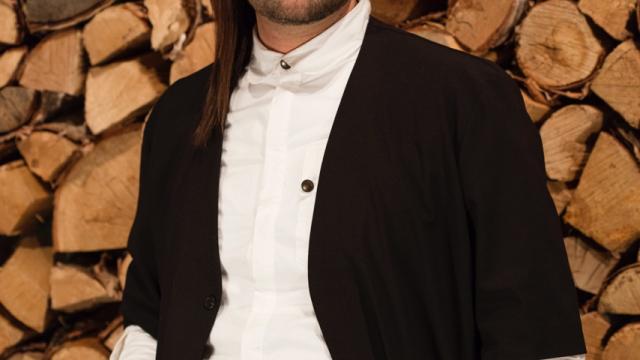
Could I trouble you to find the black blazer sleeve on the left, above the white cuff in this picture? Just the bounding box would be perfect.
[120,99,161,339]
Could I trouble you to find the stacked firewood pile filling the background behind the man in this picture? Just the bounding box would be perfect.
[0,0,640,360]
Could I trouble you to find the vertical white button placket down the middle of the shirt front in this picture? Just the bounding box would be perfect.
[242,81,292,360]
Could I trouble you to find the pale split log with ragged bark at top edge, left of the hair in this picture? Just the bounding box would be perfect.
[144,0,200,52]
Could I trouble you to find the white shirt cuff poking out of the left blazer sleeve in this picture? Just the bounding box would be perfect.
[109,325,157,360]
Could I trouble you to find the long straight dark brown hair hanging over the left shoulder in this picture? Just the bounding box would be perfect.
[192,0,256,148]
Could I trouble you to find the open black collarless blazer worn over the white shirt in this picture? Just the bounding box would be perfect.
[121,17,586,360]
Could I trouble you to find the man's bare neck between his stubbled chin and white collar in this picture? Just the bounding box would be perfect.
[256,0,358,54]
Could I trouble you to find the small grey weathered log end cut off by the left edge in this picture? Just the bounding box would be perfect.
[0,86,37,133]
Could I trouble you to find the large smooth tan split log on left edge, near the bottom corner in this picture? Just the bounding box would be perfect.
[0,237,53,332]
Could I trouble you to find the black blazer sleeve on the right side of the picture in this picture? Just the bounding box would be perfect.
[457,61,586,360]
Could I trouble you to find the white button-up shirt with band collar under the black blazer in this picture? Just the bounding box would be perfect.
[110,0,582,360]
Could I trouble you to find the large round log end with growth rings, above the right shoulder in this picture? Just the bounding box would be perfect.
[516,0,604,90]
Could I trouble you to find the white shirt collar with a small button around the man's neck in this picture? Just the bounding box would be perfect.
[246,0,371,85]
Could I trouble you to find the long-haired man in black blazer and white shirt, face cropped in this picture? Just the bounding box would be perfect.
[111,0,585,360]
